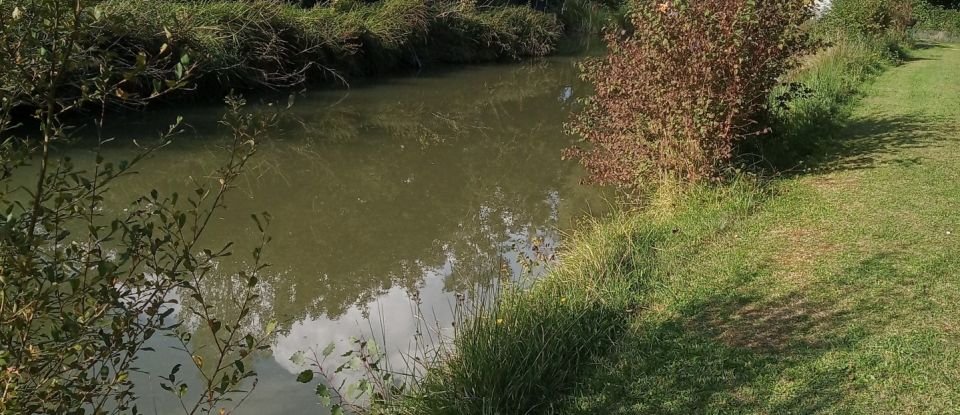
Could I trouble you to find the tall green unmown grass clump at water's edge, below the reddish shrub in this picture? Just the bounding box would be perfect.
[385,216,663,414]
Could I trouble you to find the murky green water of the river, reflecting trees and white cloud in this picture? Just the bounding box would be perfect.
[67,50,606,415]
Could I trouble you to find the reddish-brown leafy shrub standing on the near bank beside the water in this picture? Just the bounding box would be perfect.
[568,0,812,187]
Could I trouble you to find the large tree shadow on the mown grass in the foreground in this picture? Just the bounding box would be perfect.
[571,254,916,414]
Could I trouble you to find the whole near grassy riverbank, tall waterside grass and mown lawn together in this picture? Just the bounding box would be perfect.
[387,34,960,414]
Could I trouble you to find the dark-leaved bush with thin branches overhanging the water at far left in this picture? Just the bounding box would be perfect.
[0,0,273,414]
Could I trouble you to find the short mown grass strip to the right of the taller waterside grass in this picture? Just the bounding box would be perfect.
[557,45,960,414]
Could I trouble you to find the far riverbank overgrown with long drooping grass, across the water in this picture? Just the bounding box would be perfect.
[90,0,609,96]
